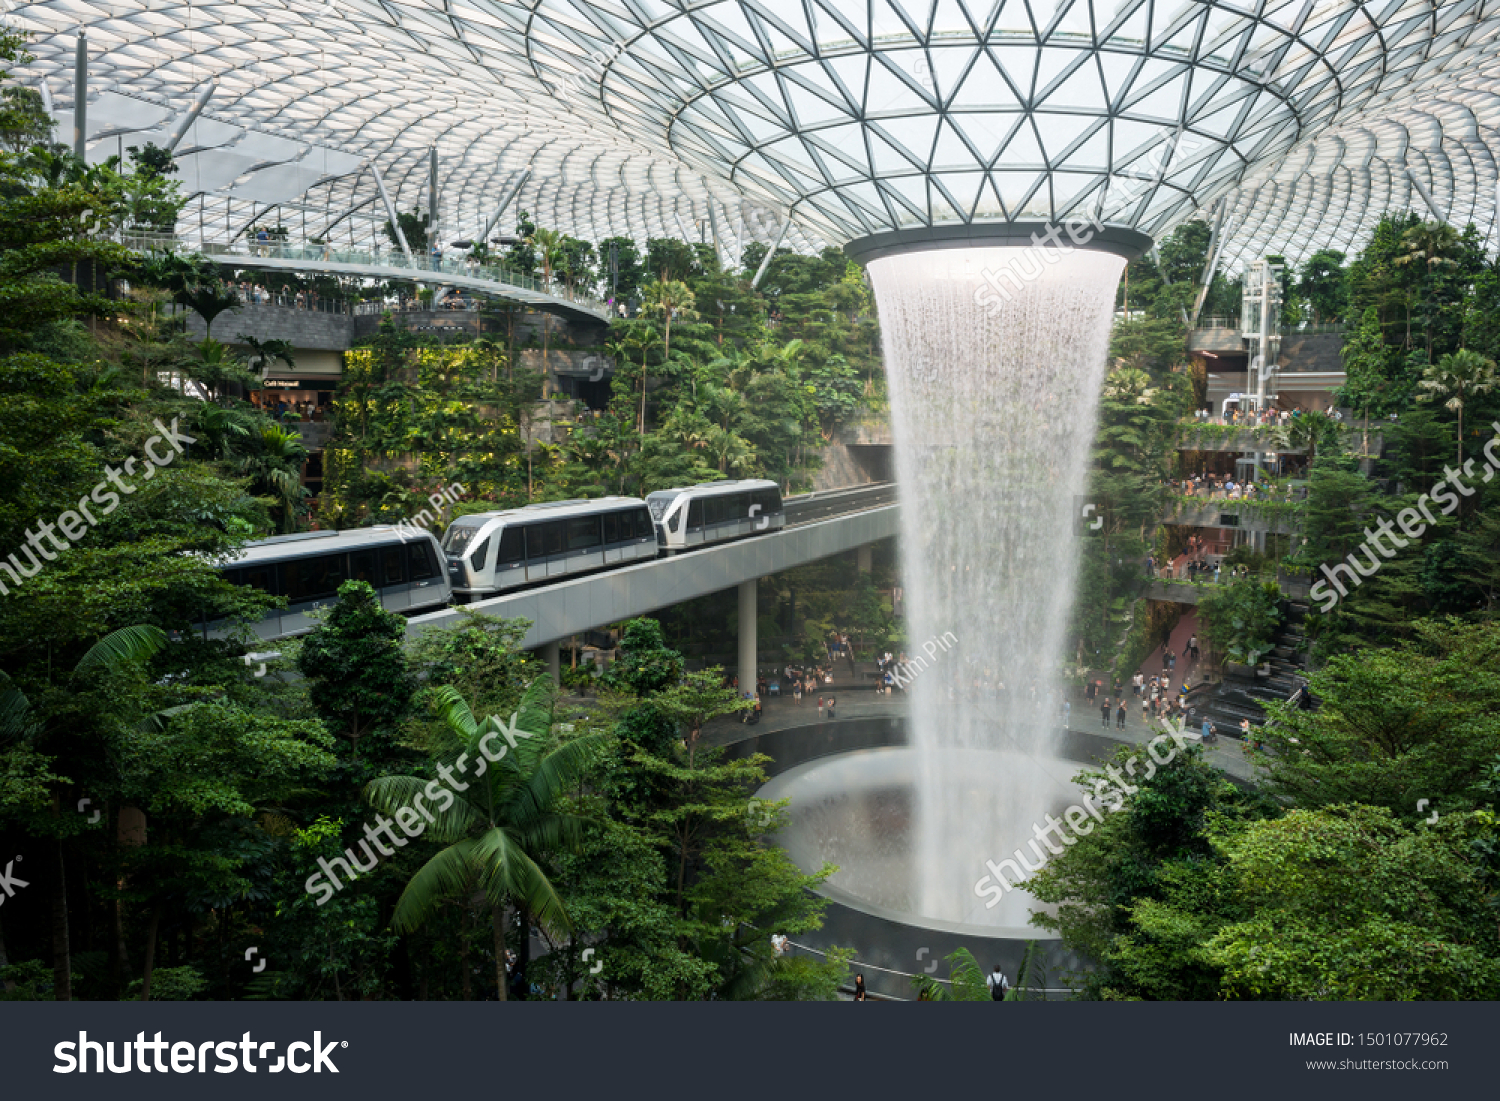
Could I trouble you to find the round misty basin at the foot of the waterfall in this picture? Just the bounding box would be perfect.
[758,746,1083,939]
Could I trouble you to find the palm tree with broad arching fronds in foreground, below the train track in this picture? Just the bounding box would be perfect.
[365,678,606,1001]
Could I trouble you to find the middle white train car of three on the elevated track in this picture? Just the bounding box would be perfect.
[443,497,657,603]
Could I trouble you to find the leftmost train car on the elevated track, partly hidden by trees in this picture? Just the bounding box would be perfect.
[203,527,453,639]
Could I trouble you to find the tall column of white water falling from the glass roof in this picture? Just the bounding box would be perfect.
[869,246,1125,927]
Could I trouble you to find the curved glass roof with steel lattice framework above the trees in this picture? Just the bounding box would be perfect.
[9,0,1500,261]
